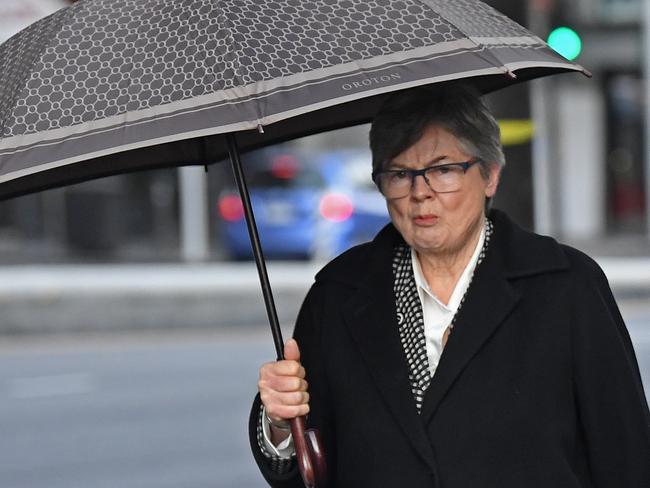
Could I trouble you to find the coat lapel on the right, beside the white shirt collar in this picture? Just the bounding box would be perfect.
[422,227,520,425]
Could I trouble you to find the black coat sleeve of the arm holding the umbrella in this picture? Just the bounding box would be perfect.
[248,285,333,488]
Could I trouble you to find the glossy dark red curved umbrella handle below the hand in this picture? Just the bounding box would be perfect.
[291,416,327,488]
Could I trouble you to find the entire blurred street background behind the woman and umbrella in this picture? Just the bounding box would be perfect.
[0,0,650,488]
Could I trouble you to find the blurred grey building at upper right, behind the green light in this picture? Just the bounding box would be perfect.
[530,0,650,244]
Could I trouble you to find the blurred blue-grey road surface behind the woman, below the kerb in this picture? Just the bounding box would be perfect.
[0,301,650,488]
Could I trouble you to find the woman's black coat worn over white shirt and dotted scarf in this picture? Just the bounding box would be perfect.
[251,211,650,488]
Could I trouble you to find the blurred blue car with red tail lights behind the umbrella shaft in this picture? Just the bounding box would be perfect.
[218,146,388,260]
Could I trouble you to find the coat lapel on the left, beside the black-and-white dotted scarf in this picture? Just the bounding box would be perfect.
[336,233,435,470]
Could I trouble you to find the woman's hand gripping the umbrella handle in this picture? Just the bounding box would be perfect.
[257,339,309,445]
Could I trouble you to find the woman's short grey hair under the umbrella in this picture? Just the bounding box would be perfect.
[370,85,506,179]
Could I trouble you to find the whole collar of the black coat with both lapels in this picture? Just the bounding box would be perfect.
[316,211,568,464]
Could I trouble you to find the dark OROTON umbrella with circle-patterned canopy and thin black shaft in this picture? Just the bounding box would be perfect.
[0,0,587,484]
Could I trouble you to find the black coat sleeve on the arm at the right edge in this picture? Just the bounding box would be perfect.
[572,255,650,488]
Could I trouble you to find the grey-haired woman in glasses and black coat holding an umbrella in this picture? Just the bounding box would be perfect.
[250,88,650,488]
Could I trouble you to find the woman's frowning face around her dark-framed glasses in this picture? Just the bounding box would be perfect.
[386,125,500,255]
